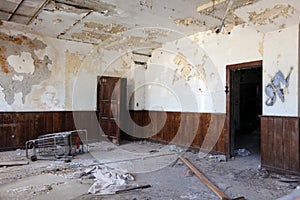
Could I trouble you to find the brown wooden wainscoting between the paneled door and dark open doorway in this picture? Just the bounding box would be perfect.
[130,111,228,154]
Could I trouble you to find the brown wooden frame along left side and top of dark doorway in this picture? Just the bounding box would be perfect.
[224,60,263,157]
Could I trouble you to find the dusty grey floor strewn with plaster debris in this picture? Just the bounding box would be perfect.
[0,141,298,200]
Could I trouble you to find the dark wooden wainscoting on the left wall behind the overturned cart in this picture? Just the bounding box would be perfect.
[0,111,99,151]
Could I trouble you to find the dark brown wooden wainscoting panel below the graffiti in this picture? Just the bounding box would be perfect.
[261,116,300,175]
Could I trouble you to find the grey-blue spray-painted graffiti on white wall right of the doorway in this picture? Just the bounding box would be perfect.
[265,67,293,106]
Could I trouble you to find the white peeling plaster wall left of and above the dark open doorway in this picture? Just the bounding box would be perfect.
[145,26,263,113]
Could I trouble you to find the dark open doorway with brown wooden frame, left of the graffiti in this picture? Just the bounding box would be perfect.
[227,62,262,156]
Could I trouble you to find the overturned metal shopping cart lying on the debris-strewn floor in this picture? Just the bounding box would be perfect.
[26,129,88,161]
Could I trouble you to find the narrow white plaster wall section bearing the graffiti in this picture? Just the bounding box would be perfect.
[262,25,299,117]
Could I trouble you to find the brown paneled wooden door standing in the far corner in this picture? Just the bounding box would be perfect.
[97,76,126,144]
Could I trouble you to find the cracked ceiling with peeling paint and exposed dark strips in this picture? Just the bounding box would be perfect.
[0,0,300,47]
